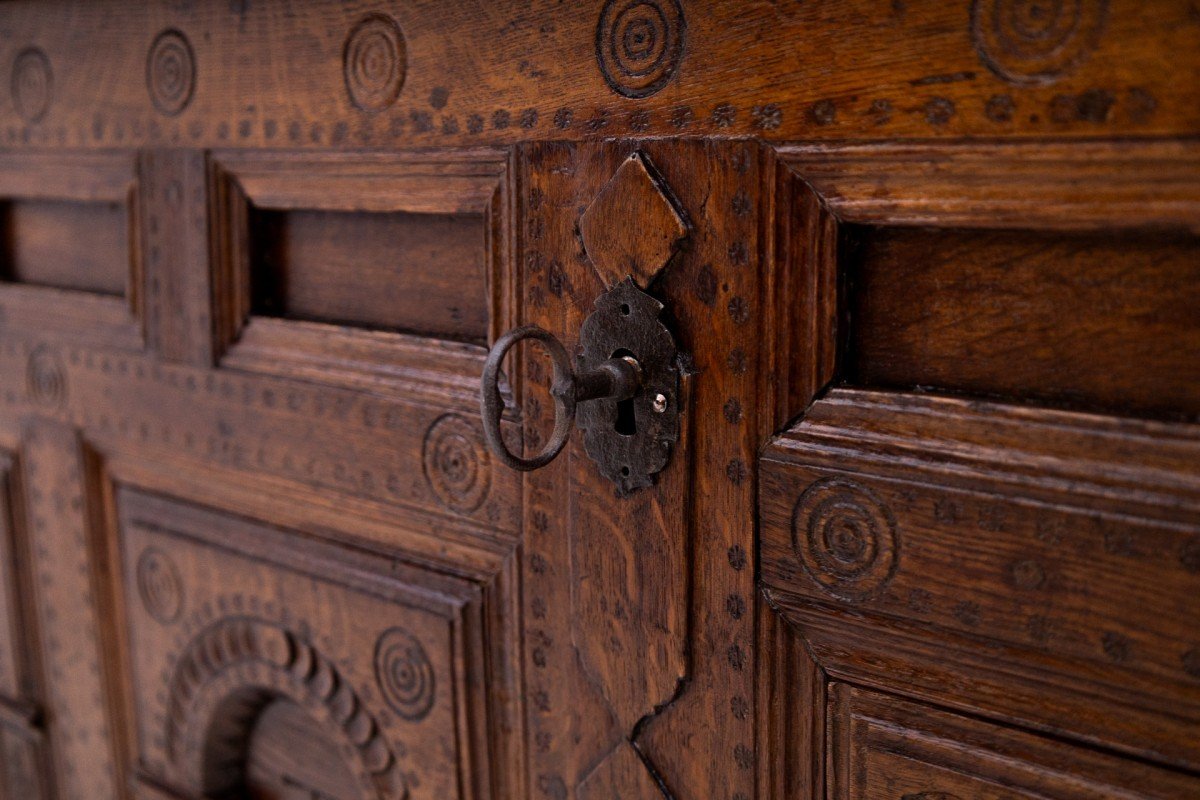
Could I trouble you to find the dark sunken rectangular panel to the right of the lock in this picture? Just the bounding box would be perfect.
[842,227,1200,416]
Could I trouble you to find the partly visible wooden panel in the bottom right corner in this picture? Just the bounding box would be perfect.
[828,684,1200,800]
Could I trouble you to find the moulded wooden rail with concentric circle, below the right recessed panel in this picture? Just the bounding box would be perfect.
[760,390,1200,769]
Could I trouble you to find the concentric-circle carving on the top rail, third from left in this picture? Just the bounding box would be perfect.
[342,14,408,112]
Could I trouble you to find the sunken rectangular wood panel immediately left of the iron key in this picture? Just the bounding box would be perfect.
[251,210,487,342]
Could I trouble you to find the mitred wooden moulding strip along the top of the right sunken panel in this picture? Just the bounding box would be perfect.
[775,138,1200,233]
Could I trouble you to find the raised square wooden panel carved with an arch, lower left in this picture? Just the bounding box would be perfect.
[118,488,487,798]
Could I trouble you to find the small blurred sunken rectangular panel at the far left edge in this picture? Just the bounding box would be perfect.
[0,200,130,295]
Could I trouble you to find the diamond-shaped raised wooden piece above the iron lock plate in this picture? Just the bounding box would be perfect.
[580,152,688,289]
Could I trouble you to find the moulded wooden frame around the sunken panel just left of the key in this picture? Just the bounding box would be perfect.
[210,149,520,385]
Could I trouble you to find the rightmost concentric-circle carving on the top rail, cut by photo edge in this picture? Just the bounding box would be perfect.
[971,0,1108,85]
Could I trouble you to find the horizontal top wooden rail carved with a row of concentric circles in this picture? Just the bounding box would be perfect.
[0,0,1200,149]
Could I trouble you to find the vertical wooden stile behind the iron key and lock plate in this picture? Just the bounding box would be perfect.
[514,140,782,799]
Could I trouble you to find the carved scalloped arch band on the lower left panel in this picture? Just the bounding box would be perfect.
[166,616,407,800]
